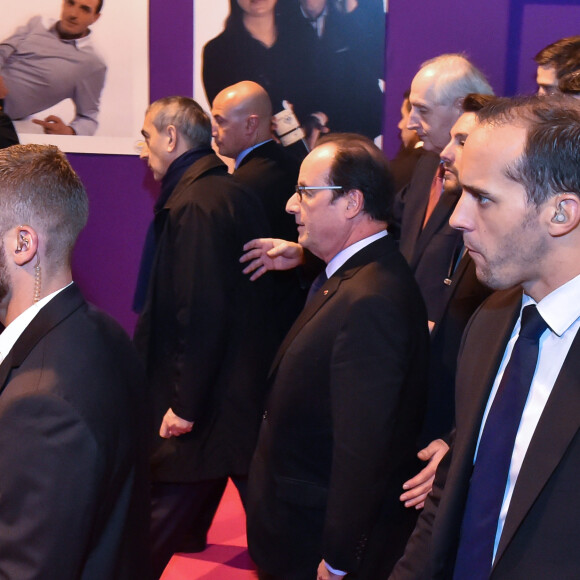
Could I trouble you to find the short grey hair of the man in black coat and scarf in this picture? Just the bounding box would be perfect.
[147,96,211,149]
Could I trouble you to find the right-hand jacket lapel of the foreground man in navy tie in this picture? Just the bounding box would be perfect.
[495,333,580,563]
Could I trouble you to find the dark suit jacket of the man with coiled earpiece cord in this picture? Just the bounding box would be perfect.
[0,285,150,580]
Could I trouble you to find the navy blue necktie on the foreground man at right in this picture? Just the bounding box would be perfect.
[453,305,547,580]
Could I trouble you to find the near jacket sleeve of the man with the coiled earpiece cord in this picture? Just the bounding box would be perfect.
[0,395,102,580]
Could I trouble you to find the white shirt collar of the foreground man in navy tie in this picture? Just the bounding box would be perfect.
[522,276,580,336]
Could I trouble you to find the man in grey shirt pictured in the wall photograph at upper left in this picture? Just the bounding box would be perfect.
[0,0,107,135]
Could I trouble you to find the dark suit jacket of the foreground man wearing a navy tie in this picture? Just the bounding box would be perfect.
[392,289,580,580]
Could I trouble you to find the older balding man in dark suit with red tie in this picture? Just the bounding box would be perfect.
[395,54,493,328]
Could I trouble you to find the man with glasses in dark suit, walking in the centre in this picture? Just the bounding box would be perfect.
[247,136,428,580]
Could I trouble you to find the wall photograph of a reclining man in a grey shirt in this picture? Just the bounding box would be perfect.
[0,0,149,154]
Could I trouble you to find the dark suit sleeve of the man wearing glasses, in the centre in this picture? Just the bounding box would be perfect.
[323,296,426,572]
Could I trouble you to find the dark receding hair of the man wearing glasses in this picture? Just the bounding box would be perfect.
[318,133,395,222]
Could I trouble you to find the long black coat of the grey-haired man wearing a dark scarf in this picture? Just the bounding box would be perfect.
[135,153,279,482]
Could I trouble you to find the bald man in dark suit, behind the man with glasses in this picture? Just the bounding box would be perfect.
[211,81,306,336]
